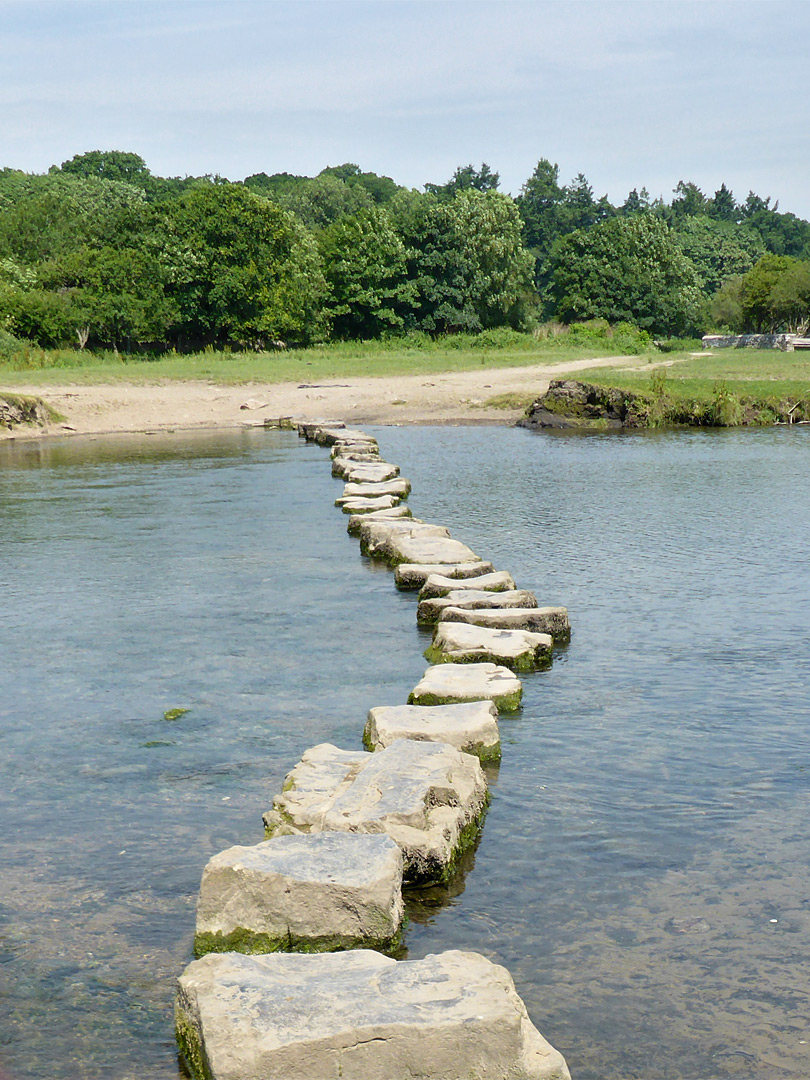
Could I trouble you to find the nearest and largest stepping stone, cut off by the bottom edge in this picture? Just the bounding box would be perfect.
[175,949,570,1080]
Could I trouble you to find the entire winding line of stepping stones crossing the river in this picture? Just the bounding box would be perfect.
[175,422,570,1080]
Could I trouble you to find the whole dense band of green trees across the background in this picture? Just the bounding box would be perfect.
[0,145,810,351]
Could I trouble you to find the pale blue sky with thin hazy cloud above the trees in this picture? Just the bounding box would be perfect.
[0,0,810,218]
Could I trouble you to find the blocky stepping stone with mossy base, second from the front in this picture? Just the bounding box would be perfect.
[194,833,404,956]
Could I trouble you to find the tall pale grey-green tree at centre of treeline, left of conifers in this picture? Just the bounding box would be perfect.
[404,190,532,334]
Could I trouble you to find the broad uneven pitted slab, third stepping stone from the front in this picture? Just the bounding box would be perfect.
[265,739,487,882]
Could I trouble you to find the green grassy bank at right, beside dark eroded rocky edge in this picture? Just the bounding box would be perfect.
[540,349,810,427]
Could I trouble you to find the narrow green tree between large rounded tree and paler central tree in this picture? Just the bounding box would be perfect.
[319,207,415,338]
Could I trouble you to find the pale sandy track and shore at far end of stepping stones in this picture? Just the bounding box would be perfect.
[0,356,647,438]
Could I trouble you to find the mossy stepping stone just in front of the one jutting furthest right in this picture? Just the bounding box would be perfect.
[424,622,553,672]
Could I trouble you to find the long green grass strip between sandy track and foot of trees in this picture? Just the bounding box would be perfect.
[0,335,638,387]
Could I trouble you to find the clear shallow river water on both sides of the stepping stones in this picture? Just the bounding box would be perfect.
[0,428,810,1080]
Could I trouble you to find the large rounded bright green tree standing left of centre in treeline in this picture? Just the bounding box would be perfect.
[162,184,325,347]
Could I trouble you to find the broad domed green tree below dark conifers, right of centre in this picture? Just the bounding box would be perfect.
[551,214,700,335]
